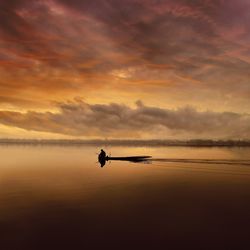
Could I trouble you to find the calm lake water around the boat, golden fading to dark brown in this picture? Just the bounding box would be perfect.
[0,146,250,250]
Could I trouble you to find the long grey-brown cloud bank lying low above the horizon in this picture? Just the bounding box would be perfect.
[0,100,250,139]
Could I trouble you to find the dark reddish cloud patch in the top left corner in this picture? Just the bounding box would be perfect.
[0,0,58,62]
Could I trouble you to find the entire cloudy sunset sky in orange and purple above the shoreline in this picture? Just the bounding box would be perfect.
[0,0,250,139]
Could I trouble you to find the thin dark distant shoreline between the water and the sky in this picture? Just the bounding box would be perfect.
[0,139,250,147]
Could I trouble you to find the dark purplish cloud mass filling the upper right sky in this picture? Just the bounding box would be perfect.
[52,0,250,81]
